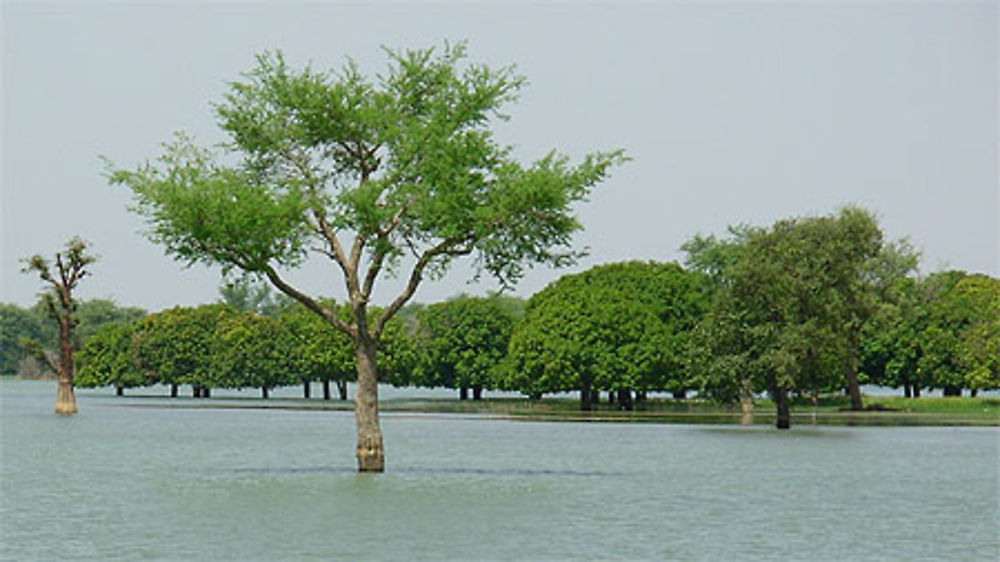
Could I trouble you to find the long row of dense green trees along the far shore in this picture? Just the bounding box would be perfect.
[0,207,1000,427]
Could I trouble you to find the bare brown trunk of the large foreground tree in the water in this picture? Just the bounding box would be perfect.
[354,334,385,472]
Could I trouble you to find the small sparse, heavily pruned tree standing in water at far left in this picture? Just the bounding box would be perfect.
[23,237,97,416]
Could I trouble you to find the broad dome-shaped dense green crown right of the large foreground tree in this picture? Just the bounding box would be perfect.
[507,262,708,394]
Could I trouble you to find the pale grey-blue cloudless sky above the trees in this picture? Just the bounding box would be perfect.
[0,0,1000,310]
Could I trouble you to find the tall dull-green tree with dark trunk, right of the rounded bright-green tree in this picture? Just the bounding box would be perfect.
[685,207,883,429]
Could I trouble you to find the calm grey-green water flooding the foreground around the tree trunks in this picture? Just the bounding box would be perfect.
[0,380,1000,561]
